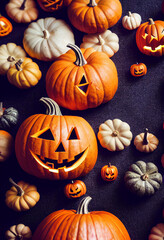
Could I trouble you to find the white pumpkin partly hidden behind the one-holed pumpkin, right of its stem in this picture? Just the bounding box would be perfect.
[80,30,119,57]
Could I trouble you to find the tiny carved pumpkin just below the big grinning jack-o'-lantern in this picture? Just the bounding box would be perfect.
[64,180,87,198]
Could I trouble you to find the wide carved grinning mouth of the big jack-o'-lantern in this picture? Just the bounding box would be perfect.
[30,148,88,172]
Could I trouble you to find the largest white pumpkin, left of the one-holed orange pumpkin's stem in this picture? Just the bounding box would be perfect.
[23,17,75,61]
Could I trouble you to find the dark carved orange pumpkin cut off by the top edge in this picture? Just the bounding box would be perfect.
[37,0,63,12]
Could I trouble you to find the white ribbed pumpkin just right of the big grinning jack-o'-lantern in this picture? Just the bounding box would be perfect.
[97,119,133,151]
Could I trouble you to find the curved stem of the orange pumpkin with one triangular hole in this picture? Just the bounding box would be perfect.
[67,43,87,67]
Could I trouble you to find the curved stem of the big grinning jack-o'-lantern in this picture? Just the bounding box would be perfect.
[40,97,62,116]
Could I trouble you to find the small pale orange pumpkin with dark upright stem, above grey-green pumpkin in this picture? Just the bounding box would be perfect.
[134,128,159,153]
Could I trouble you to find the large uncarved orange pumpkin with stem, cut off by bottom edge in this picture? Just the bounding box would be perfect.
[32,197,130,240]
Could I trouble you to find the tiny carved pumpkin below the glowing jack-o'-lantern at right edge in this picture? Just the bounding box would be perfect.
[130,63,147,77]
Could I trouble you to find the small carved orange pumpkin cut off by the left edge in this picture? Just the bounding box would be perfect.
[0,14,13,37]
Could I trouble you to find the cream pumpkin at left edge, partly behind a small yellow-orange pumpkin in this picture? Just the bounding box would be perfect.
[0,43,26,74]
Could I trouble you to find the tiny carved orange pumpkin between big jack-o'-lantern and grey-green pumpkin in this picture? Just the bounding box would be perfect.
[101,163,118,182]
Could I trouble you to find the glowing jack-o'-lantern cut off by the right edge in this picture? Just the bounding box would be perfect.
[136,18,164,57]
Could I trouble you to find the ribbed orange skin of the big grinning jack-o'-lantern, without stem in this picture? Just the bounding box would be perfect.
[15,114,98,180]
